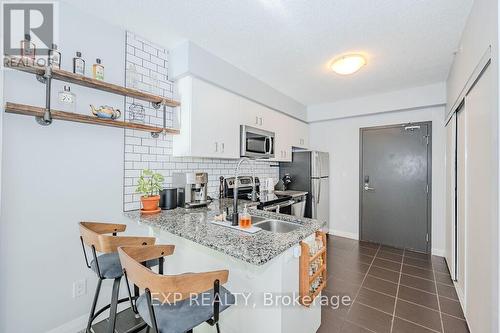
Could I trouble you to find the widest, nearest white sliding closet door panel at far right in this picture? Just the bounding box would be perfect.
[465,67,498,332]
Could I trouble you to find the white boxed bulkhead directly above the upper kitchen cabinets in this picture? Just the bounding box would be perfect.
[170,41,306,120]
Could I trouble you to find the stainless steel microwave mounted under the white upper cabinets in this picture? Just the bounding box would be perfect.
[240,125,275,158]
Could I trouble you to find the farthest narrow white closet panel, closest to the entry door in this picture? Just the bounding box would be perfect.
[445,114,457,280]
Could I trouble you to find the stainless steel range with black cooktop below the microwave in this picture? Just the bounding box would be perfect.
[224,176,294,215]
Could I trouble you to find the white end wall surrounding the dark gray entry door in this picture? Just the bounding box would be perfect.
[310,104,446,255]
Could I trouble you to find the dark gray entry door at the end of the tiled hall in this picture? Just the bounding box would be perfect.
[360,122,431,252]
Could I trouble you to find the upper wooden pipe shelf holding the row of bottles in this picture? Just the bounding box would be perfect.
[4,57,181,107]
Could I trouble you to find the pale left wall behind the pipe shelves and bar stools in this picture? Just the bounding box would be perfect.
[0,4,137,332]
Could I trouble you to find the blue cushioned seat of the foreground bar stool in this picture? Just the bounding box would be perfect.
[137,286,235,333]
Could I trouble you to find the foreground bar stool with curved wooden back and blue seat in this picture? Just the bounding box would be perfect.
[118,245,235,333]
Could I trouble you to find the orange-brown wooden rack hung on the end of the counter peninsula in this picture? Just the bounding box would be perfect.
[299,231,327,306]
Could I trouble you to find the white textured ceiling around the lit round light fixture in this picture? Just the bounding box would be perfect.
[66,0,473,105]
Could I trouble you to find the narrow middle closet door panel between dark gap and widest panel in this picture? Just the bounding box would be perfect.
[455,106,468,301]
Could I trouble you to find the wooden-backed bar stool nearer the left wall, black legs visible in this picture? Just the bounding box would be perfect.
[79,222,159,333]
